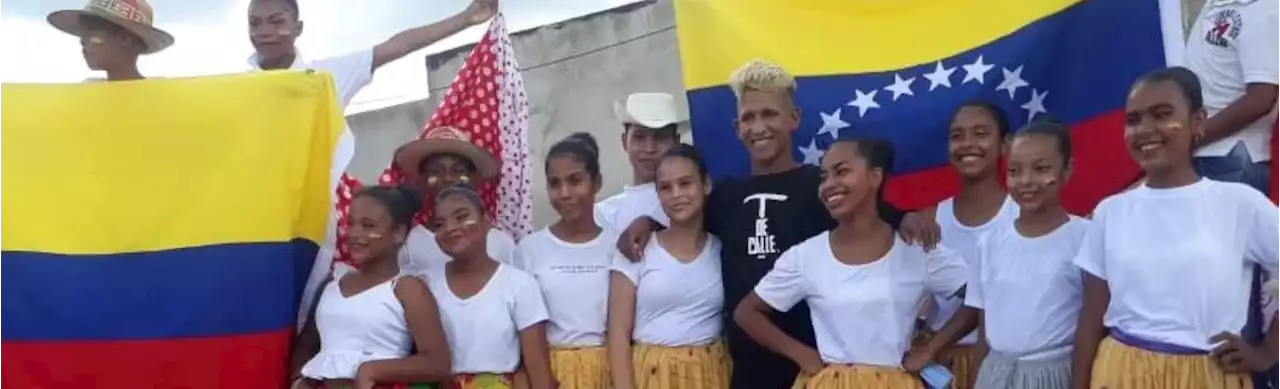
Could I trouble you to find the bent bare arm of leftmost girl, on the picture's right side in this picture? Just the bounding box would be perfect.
[356,276,453,384]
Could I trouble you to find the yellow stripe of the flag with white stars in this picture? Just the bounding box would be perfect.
[675,0,1079,90]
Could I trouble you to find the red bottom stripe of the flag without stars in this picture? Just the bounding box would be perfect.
[0,329,293,389]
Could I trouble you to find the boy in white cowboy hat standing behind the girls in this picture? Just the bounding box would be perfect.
[595,93,680,232]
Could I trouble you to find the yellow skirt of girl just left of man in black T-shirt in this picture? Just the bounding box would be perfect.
[631,342,731,389]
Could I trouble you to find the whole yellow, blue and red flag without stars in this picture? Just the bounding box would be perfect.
[0,73,343,389]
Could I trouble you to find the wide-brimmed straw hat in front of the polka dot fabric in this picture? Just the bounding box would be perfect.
[396,127,498,180]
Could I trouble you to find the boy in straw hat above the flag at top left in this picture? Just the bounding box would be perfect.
[47,0,173,81]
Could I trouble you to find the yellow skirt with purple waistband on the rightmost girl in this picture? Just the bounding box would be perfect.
[1089,338,1253,389]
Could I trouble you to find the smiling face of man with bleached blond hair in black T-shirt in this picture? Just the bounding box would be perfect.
[735,90,800,164]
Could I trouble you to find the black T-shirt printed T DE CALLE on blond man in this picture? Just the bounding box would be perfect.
[707,165,902,389]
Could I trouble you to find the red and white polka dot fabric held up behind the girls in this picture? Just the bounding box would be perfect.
[334,14,534,264]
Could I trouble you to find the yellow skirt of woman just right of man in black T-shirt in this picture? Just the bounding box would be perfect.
[791,365,924,389]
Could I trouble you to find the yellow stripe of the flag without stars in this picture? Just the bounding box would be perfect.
[0,72,343,255]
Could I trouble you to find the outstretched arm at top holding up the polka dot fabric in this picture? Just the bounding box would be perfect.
[374,0,498,69]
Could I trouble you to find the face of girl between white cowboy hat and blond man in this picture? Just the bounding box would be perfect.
[657,156,710,224]
